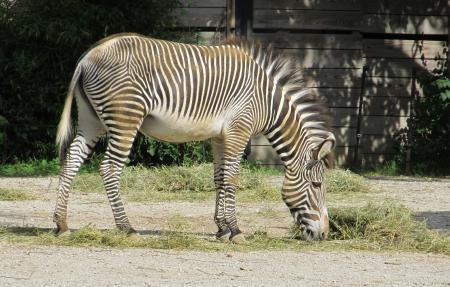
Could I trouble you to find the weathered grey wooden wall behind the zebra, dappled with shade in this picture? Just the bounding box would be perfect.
[177,0,449,168]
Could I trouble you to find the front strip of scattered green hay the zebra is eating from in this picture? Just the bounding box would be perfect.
[0,205,450,255]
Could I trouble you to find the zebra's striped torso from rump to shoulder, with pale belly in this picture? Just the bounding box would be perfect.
[83,35,268,142]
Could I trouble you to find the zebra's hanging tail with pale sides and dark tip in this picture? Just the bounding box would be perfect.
[56,64,81,166]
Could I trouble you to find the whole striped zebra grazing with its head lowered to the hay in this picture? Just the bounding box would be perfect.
[53,33,336,243]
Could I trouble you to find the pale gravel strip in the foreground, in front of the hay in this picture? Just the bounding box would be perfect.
[0,245,450,287]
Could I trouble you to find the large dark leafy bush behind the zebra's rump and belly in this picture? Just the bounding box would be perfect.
[0,0,212,164]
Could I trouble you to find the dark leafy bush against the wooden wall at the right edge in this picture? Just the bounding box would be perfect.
[397,72,450,174]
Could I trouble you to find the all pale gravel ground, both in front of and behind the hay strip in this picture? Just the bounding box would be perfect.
[0,177,450,286]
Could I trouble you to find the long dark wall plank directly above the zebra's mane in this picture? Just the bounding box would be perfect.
[252,31,362,50]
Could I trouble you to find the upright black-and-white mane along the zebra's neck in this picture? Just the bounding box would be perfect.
[222,38,334,167]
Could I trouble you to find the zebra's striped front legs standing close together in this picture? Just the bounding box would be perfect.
[214,129,249,243]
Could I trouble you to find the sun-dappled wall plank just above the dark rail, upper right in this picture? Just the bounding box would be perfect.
[364,14,448,35]
